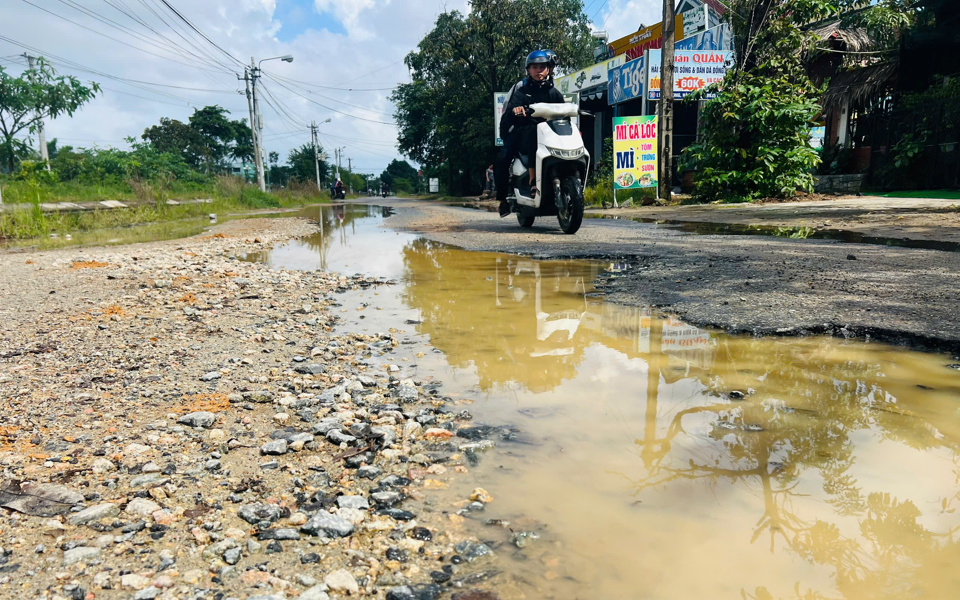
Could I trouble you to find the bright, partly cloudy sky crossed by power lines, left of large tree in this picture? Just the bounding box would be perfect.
[0,0,466,173]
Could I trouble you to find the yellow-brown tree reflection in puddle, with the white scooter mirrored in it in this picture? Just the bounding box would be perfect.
[403,239,599,392]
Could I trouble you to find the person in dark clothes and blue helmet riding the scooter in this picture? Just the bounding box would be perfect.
[494,50,564,217]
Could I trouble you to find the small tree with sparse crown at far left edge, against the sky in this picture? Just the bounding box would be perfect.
[0,57,100,171]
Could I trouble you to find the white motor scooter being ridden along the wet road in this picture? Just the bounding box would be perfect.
[507,102,590,233]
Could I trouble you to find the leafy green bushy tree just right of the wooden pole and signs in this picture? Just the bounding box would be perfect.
[682,0,858,201]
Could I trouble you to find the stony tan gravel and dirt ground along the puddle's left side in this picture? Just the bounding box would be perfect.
[0,219,506,600]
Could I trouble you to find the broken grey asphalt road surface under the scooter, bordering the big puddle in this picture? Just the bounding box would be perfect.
[378,200,960,353]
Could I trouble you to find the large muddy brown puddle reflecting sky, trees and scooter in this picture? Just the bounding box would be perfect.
[250,206,960,600]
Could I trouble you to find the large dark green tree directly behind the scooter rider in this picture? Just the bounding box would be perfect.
[392,0,593,193]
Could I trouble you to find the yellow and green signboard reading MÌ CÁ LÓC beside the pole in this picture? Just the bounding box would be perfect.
[613,115,657,190]
